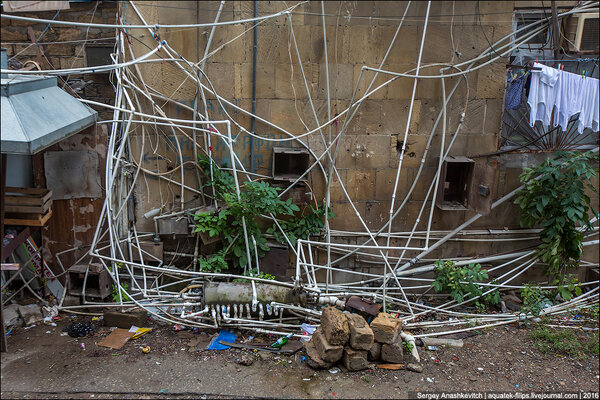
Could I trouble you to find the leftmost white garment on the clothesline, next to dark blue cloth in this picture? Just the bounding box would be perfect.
[527,62,560,129]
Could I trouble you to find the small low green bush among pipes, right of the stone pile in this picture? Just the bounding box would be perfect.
[432,260,488,303]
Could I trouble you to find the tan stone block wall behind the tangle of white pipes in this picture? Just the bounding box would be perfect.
[119,1,598,276]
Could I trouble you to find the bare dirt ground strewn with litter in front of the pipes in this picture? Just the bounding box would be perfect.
[1,316,599,398]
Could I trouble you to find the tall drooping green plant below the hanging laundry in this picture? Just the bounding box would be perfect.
[515,152,598,285]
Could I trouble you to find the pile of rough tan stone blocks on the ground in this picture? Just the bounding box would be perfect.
[304,307,418,371]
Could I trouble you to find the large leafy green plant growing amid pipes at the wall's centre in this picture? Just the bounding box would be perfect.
[194,157,333,274]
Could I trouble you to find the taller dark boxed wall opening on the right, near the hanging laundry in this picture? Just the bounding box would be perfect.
[436,156,475,210]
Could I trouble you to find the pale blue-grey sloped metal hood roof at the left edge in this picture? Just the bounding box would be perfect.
[0,74,98,155]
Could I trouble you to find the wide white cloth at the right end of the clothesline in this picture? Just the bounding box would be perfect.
[553,71,600,133]
